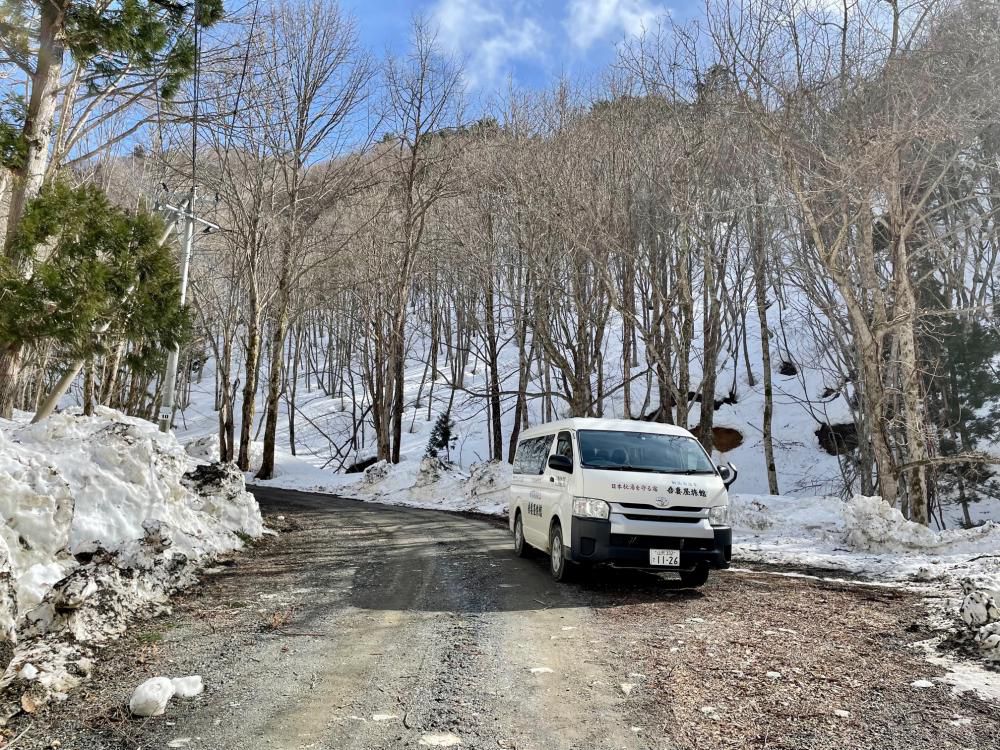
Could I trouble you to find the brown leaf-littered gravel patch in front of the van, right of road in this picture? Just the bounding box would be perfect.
[604,573,1000,750]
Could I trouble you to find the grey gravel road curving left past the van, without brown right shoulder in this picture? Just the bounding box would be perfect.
[90,488,663,750]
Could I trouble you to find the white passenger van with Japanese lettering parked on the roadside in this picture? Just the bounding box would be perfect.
[509,418,736,586]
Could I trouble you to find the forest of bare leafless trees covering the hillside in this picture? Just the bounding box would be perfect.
[0,0,1000,523]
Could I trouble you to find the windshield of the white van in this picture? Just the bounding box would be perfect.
[577,430,715,474]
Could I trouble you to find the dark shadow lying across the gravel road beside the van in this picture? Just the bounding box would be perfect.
[243,488,712,626]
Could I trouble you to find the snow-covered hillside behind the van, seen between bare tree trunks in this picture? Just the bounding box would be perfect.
[158,300,1000,564]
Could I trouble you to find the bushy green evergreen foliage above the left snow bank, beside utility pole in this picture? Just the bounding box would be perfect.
[0,182,189,368]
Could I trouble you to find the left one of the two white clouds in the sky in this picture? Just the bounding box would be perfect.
[432,0,545,87]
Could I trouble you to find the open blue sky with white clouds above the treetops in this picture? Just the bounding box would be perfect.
[342,0,699,94]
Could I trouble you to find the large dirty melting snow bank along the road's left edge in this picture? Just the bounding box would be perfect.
[0,410,263,715]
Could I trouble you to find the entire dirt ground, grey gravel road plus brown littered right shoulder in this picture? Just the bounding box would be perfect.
[9,490,1000,750]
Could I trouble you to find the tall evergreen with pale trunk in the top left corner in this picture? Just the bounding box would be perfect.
[0,0,223,416]
